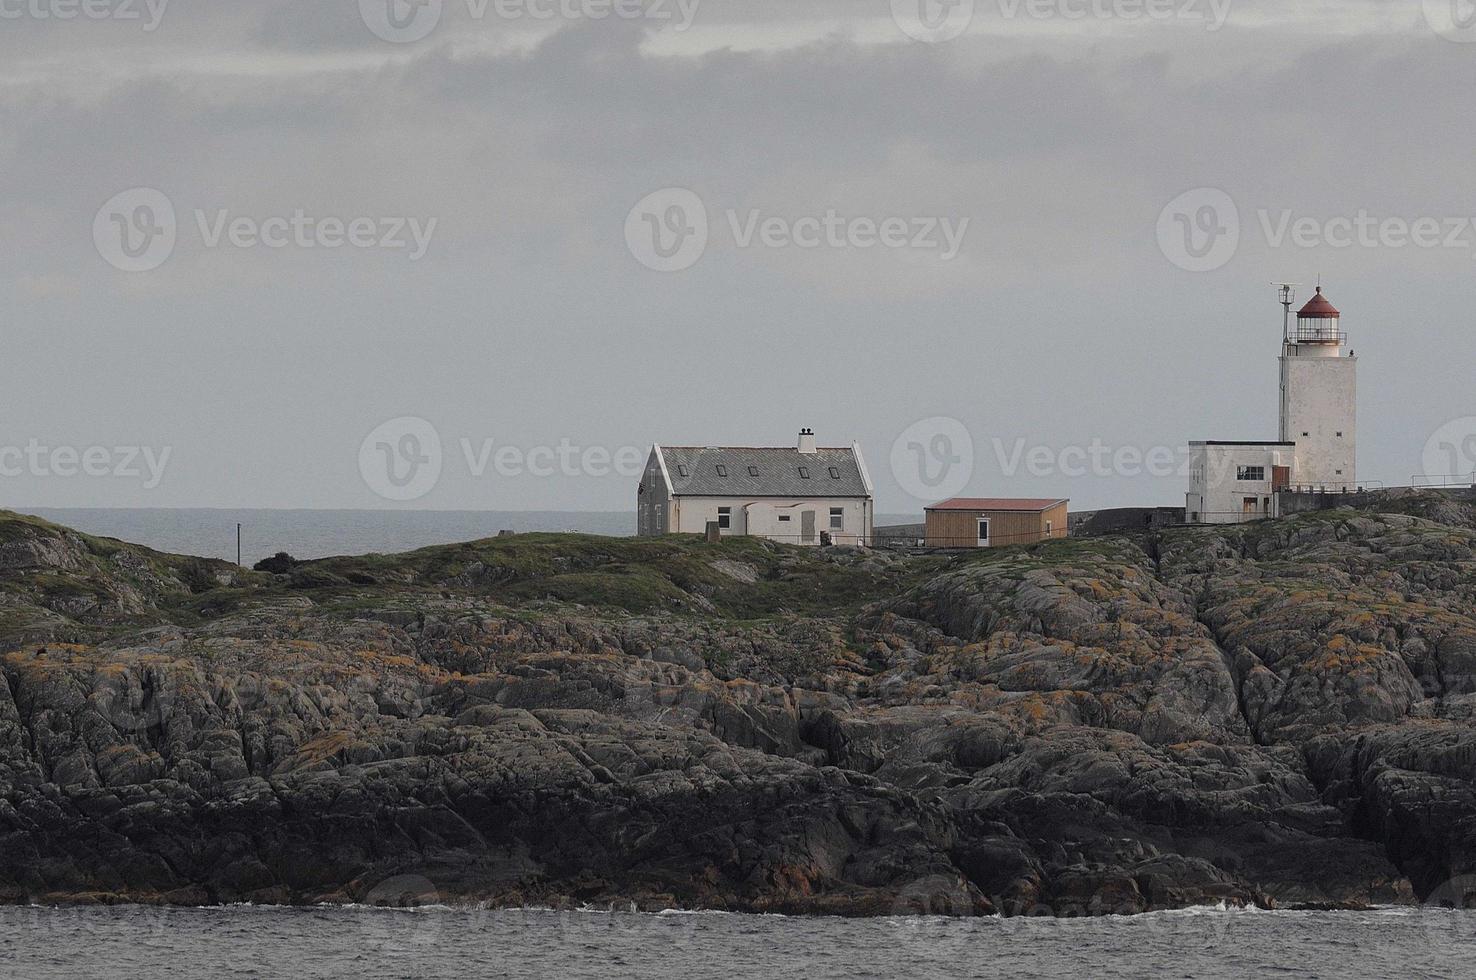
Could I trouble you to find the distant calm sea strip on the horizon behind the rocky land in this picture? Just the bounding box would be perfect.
[17,506,921,565]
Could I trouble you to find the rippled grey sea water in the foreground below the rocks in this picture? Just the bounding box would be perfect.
[0,906,1476,980]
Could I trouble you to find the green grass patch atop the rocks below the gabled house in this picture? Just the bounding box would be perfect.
[0,512,1163,626]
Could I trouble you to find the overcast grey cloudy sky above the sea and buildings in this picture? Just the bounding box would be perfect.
[0,0,1476,514]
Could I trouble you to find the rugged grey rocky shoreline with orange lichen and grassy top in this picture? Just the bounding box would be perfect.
[0,494,1476,915]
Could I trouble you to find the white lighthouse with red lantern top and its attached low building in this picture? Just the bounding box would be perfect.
[1184,286,1358,524]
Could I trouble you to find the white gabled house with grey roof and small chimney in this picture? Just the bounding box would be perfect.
[636,429,875,545]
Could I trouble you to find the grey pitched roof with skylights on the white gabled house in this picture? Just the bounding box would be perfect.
[660,446,871,497]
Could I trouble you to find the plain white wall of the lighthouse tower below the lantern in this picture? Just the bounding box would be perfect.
[1281,344,1358,490]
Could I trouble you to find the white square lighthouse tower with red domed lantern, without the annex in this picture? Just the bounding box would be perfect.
[1281,286,1358,491]
